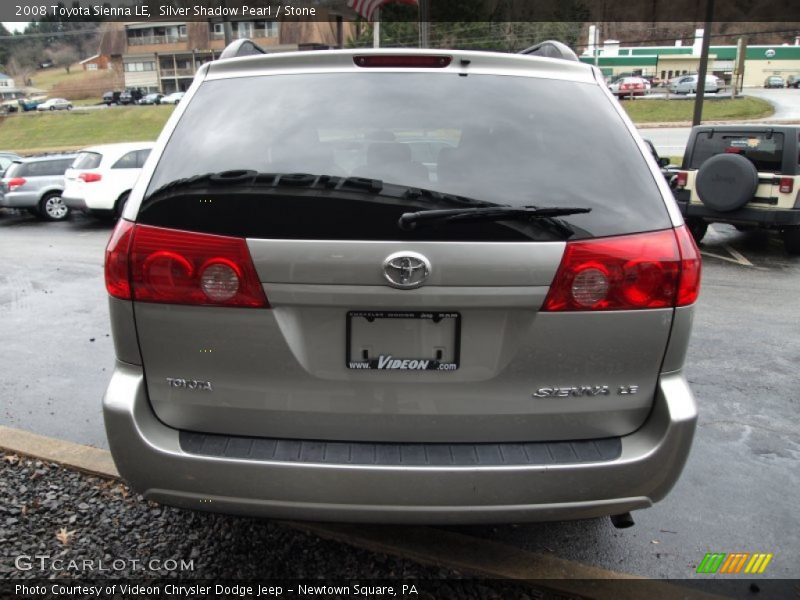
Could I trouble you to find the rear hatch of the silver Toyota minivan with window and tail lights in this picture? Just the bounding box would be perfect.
[112,55,694,442]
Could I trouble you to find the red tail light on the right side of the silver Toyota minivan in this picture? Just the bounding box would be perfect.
[542,227,700,312]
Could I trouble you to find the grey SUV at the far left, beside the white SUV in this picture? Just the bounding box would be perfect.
[0,154,75,221]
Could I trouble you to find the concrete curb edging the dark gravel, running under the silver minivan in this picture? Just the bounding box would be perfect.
[0,425,720,600]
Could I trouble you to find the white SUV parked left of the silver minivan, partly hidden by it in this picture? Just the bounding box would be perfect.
[63,142,153,218]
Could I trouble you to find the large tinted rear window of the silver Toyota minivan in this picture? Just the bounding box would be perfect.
[139,72,670,240]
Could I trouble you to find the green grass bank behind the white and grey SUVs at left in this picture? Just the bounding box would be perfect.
[0,106,174,154]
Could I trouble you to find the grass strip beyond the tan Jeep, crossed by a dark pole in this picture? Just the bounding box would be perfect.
[622,96,775,123]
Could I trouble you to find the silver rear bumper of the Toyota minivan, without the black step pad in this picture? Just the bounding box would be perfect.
[103,362,697,524]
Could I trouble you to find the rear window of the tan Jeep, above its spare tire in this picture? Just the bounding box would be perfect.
[689,131,783,172]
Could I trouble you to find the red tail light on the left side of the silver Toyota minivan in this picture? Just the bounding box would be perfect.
[105,220,269,308]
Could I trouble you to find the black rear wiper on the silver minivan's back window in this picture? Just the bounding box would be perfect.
[397,206,592,237]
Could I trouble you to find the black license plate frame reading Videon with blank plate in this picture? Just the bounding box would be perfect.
[345,310,461,371]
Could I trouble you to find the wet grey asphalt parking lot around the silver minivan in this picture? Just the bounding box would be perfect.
[0,211,800,578]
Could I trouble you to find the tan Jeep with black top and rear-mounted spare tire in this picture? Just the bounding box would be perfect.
[675,125,800,254]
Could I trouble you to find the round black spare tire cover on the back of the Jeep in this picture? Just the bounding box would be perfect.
[695,154,758,212]
